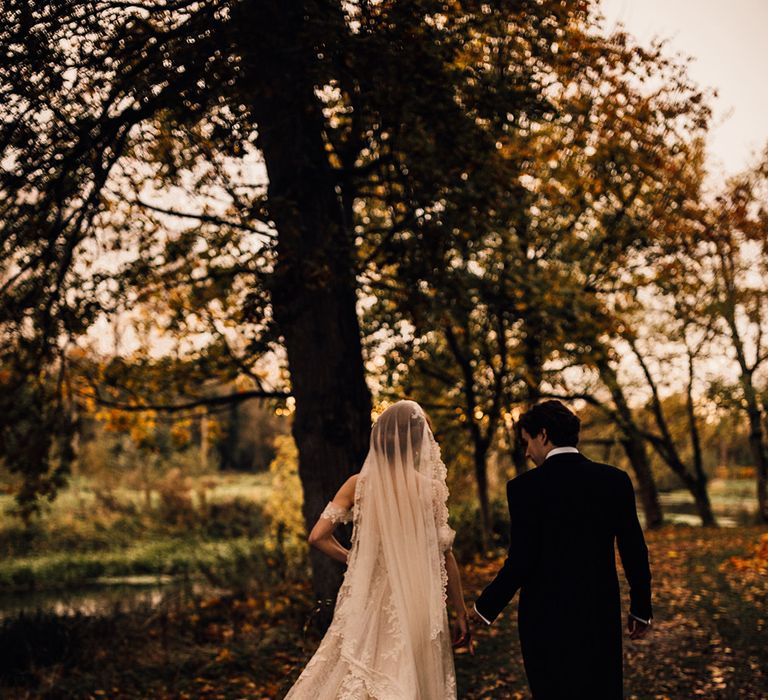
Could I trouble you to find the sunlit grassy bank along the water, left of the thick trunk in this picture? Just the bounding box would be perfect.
[0,474,303,594]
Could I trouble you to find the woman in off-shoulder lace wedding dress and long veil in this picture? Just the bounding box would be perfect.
[285,401,473,700]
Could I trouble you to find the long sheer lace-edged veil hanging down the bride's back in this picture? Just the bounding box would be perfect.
[329,400,456,700]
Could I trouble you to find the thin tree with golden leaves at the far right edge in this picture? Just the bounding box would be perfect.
[655,142,768,522]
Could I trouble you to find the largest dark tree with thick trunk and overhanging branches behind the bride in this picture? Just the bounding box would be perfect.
[0,0,600,597]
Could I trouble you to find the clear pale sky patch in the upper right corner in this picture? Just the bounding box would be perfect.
[601,0,768,182]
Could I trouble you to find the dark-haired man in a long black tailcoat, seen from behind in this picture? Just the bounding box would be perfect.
[473,401,651,700]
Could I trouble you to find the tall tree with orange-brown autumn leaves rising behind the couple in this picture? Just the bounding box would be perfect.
[367,2,709,524]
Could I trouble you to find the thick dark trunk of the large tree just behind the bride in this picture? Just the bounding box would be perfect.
[238,0,371,622]
